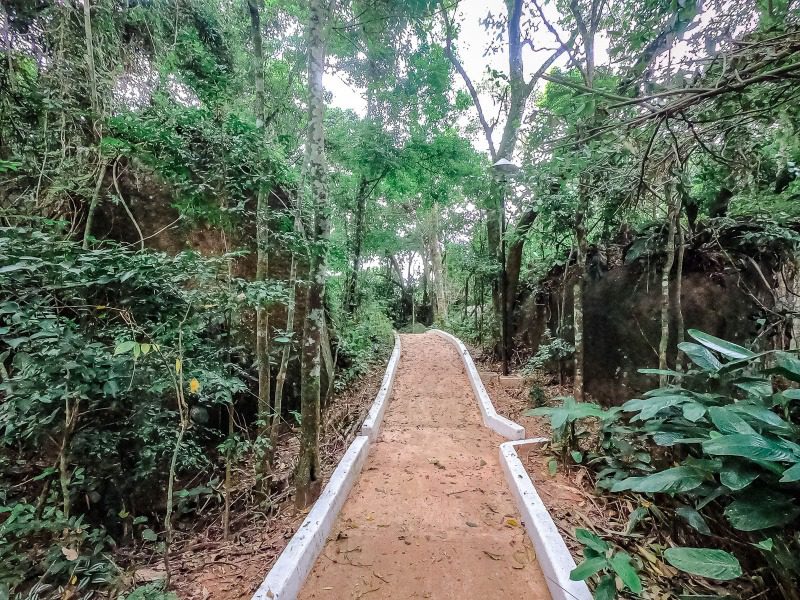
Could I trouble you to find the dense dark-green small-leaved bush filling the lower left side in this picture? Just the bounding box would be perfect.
[0,227,256,598]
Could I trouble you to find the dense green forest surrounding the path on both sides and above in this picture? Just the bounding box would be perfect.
[0,0,800,600]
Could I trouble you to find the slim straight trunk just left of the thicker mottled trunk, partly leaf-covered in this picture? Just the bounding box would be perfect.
[247,0,272,491]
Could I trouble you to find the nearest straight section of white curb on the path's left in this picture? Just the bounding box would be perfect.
[252,435,369,600]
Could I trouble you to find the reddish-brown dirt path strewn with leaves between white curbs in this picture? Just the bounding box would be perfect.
[300,334,550,600]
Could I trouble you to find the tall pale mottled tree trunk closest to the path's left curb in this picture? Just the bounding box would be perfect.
[295,0,329,507]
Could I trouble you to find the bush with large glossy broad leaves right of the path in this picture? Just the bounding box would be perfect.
[532,330,800,597]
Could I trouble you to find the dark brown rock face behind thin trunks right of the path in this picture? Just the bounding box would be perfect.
[514,225,790,405]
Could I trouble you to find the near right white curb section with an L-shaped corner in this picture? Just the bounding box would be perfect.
[500,438,592,600]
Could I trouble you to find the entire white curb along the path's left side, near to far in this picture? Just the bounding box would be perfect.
[252,332,401,600]
